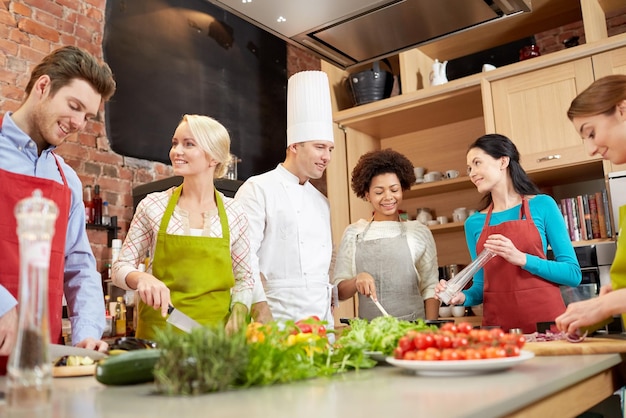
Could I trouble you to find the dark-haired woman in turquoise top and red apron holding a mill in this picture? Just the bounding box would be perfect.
[437,134,581,333]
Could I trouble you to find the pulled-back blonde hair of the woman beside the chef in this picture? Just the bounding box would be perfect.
[179,115,233,178]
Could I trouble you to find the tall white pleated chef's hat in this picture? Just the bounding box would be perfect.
[287,71,334,146]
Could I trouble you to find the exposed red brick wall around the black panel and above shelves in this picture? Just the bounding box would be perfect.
[0,0,626,269]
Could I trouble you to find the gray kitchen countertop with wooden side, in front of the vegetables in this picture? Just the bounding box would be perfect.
[0,354,622,418]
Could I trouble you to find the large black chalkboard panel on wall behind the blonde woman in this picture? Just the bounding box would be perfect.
[103,0,287,179]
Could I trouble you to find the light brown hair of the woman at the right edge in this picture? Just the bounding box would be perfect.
[567,74,626,120]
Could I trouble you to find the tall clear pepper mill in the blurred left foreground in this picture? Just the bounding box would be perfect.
[7,190,58,416]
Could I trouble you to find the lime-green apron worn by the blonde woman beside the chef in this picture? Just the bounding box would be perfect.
[136,185,235,339]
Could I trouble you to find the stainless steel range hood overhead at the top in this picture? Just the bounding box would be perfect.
[204,0,528,68]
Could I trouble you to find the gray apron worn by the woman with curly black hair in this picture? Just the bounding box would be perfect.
[355,222,426,321]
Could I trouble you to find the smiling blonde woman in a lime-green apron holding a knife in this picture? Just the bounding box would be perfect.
[113,115,254,339]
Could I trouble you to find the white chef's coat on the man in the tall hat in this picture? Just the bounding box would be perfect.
[235,164,334,328]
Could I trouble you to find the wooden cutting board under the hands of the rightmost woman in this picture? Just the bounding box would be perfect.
[523,337,626,356]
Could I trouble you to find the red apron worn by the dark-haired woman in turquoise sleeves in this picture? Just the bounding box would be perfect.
[476,197,565,334]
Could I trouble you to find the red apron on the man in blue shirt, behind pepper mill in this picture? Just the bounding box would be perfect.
[0,117,71,375]
